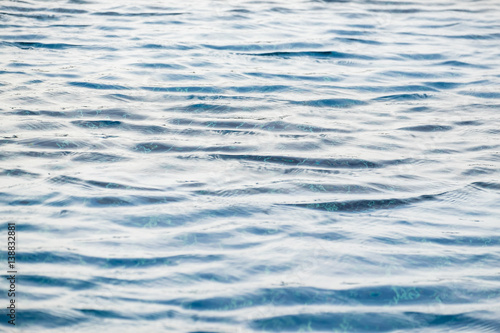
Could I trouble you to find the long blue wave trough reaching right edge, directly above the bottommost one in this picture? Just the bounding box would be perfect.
[171,285,500,311]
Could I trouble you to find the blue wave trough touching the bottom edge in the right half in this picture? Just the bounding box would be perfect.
[250,312,500,332]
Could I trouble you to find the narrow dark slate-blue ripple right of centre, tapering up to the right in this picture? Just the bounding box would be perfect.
[286,195,437,213]
